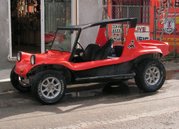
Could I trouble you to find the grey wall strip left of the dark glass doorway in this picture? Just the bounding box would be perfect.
[0,0,12,70]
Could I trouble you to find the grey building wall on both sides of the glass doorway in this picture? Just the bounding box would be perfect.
[0,0,102,70]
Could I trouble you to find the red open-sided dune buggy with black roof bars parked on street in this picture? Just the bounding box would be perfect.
[11,18,169,104]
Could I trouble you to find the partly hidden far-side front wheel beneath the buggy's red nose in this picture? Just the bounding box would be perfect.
[10,68,30,93]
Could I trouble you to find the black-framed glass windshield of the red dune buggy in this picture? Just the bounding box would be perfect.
[51,30,74,52]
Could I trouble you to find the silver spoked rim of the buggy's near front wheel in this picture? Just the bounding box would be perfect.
[40,77,62,99]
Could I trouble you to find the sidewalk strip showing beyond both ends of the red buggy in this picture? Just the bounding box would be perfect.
[0,61,179,93]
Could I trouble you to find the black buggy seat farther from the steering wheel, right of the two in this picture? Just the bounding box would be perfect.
[94,39,114,60]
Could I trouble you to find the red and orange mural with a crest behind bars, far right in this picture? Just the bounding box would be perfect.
[155,0,179,53]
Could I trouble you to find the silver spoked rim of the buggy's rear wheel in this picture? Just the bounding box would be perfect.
[144,66,161,86]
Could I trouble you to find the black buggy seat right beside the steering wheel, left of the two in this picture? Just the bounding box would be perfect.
[83,44,100,61]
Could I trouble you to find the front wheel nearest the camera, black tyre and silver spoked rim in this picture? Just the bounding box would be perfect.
[31,70,66,104]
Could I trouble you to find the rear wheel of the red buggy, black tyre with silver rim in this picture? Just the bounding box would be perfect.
[135,59,166,92]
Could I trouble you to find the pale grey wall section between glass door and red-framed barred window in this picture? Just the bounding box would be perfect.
[79,0,103,47]
